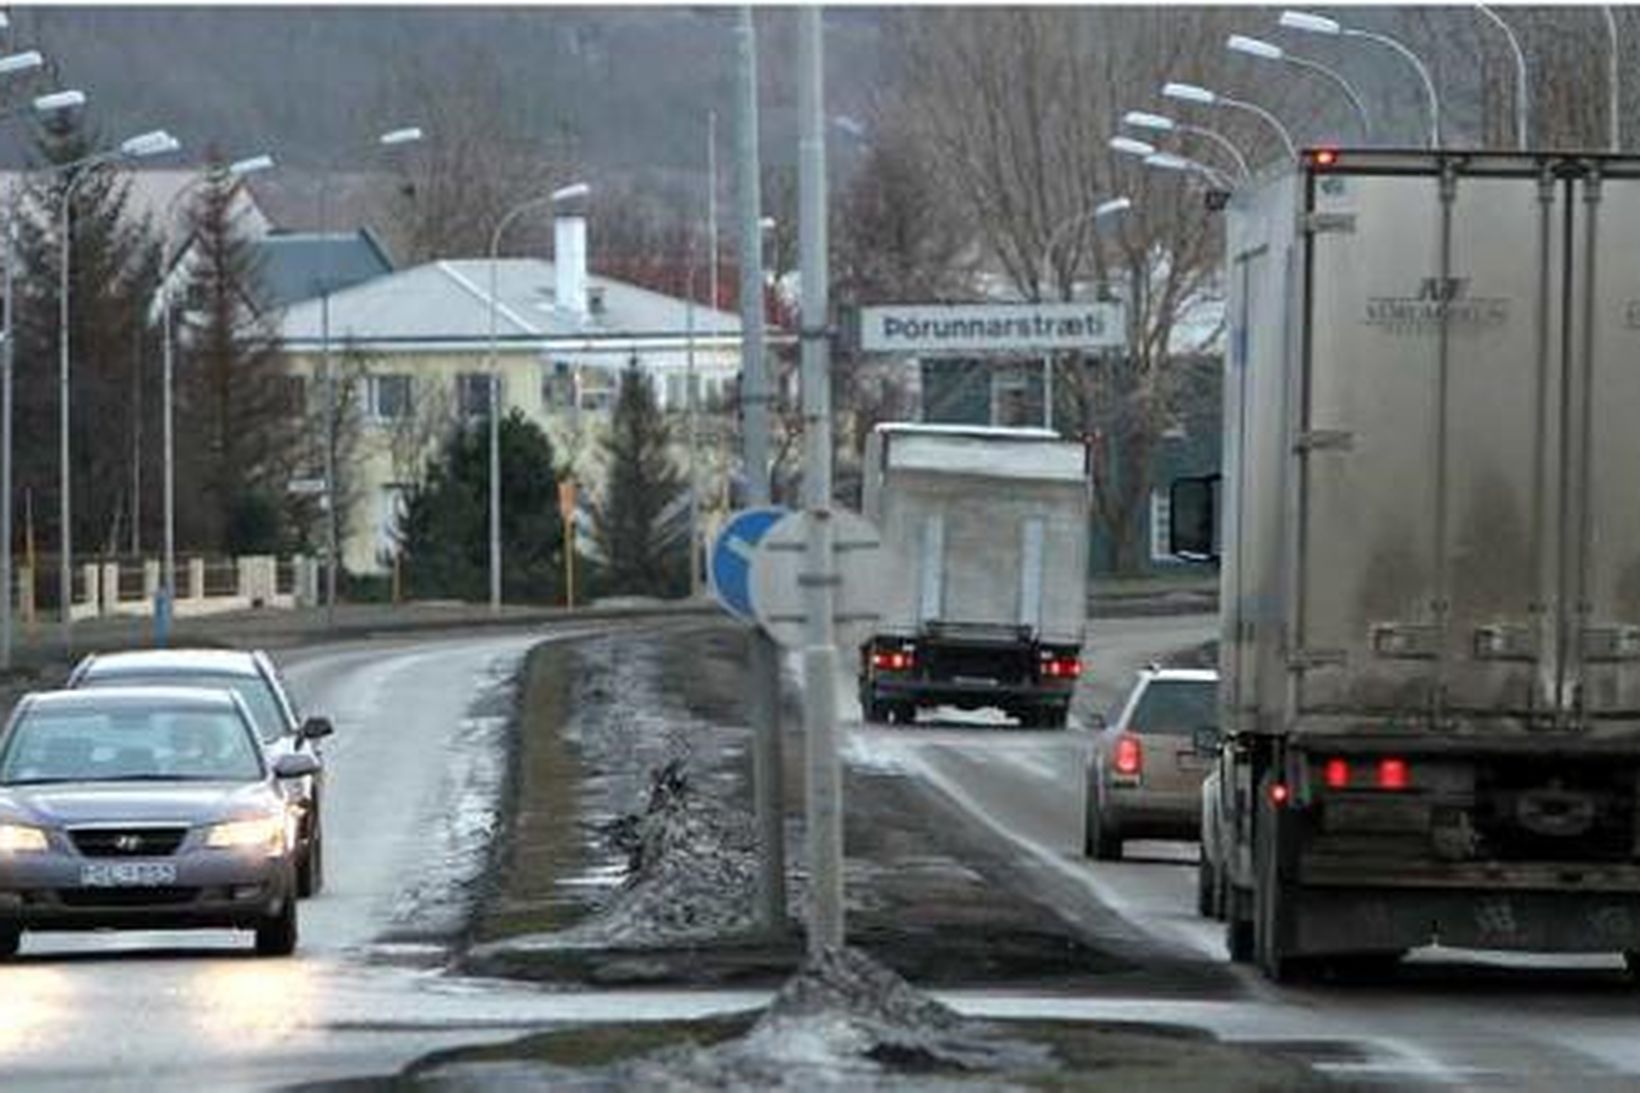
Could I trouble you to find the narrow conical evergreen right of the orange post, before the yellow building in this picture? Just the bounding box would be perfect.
[592,358,689,596]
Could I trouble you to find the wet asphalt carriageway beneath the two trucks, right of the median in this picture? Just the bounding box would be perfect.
[840,615,1640,1091]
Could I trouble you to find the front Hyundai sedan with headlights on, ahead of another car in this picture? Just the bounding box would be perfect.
[0,688,318,957]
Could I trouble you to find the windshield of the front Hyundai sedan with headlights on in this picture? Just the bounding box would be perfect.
[0,706,262,786]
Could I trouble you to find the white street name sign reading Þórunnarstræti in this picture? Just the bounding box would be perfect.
[859,300,1127,354]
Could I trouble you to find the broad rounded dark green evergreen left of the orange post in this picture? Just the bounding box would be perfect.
[399,410,564,604]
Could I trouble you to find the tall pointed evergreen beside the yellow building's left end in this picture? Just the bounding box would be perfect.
[172,150,302,555]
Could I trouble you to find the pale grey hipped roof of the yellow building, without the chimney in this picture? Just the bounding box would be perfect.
[280,258,740,345]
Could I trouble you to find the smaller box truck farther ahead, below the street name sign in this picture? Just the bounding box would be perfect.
[859,423,1089,727]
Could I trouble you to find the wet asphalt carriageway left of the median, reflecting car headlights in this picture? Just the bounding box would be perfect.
[0,633,610,1093]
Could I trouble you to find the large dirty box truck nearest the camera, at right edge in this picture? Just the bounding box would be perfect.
[1173,149,1640,980]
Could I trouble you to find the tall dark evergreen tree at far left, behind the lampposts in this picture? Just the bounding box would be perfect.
[15,118,161,564]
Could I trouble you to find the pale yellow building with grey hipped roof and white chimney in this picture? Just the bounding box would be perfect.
[280,217,740,573]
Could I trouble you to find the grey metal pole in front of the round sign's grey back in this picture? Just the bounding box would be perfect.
[797,7,843,955]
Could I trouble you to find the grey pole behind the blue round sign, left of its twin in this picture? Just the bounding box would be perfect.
[736,7,786,934]
